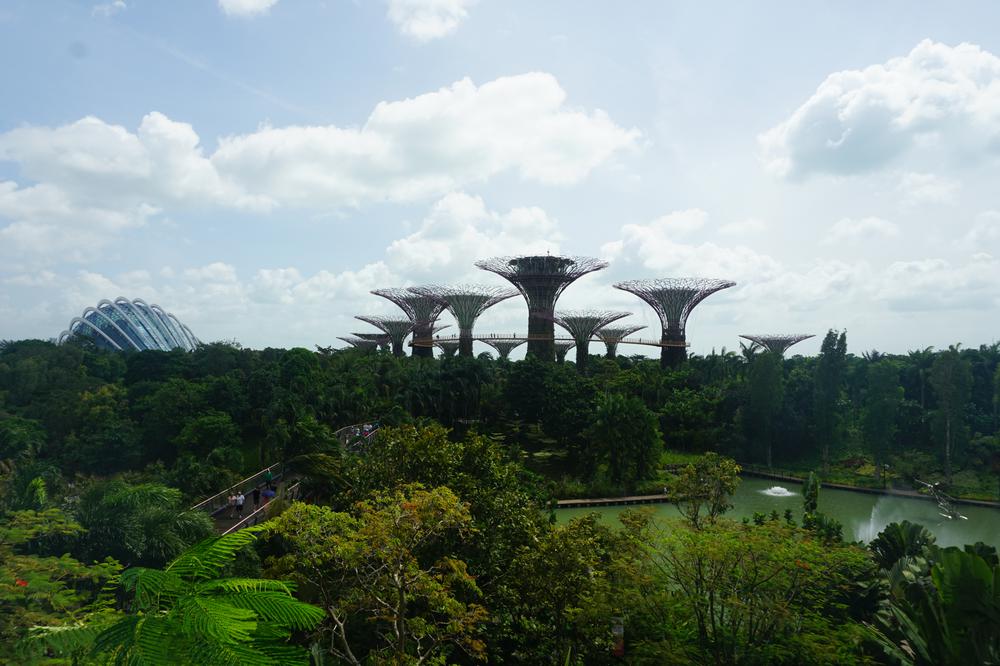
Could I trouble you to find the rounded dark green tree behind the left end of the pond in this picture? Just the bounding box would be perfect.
[587,393,662,493]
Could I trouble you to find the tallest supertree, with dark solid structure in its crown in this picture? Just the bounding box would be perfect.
[476,254,608,361]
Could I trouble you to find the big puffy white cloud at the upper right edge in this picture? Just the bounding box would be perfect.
[759,40,1000,177]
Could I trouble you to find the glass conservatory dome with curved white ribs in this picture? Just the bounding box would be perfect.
[59,297,201,351]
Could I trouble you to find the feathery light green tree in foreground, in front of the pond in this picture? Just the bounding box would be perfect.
[649,520,874,664]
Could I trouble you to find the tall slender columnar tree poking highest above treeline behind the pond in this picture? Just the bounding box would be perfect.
[813,330,847,472]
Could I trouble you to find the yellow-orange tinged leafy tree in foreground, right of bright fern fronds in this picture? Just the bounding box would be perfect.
[267,485,486,664]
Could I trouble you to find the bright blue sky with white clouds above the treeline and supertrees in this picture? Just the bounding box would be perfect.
[0,0,1000,357]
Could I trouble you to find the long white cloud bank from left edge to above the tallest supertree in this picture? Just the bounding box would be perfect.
[0,73,639,261]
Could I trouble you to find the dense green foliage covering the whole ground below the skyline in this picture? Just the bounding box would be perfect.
[0,332,1000,664]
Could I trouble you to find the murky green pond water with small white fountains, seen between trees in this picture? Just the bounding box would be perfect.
[556,478,1000,548]
